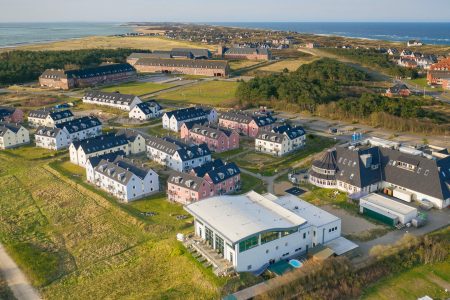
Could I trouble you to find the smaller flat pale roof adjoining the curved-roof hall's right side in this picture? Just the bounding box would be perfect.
[273,194,340,227]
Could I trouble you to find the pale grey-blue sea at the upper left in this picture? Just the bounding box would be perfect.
[0,23,133,48]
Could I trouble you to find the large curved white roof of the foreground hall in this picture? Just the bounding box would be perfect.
[185,191,306,243]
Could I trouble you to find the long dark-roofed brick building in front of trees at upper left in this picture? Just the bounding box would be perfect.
[39,63,136,90]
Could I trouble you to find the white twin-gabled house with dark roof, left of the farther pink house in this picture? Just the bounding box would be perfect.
[162,107,218,132]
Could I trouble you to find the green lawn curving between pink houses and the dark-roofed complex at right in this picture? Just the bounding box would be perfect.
[234,135,335,176]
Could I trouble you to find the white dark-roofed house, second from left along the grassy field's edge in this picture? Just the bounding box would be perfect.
[35,117,102,150]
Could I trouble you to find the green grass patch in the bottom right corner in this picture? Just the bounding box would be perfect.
[362,261,450,300]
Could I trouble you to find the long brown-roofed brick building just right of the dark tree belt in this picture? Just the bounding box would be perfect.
[134,58,230,77]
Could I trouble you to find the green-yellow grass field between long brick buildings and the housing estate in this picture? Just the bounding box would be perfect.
[157,81,238,107]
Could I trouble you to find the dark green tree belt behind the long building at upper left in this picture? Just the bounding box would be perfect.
[0,49,145,85]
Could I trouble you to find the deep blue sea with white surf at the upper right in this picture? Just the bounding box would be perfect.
[209,22,450,45]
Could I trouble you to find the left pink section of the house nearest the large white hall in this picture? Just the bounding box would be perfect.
[167,172,215,204]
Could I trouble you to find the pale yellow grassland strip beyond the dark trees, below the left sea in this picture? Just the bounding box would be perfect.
[0,36,216,52]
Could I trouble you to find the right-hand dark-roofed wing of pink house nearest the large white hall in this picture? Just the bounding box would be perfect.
[191,159,241,195]
